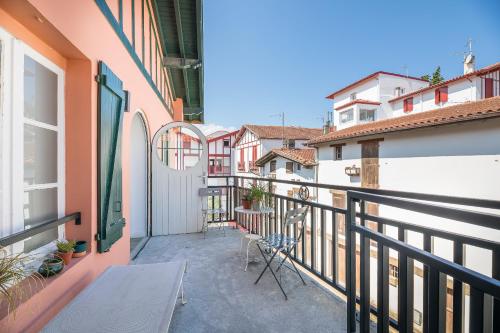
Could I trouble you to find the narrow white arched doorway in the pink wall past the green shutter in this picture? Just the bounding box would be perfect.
[130,112,149,258]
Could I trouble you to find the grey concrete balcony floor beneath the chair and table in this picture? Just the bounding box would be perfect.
[133,227,352,333]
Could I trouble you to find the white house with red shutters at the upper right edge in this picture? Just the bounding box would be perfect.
[389,62,500,117]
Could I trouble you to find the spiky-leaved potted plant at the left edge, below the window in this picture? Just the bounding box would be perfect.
[0,248,43,315]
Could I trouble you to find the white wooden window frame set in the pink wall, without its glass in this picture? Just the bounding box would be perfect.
[0,27,65,255]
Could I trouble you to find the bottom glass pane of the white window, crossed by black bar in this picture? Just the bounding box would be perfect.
[23,188,58,252]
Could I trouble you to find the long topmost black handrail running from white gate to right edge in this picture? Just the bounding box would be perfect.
[211,175,500,209]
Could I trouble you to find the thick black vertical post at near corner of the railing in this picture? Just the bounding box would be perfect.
[346,191,356,332]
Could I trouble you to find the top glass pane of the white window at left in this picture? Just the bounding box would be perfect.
[24,56,57,125]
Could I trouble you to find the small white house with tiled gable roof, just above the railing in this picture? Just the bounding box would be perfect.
[255,148,317,200]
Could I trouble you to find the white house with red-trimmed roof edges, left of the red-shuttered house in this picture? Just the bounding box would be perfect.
[327,71,429,130]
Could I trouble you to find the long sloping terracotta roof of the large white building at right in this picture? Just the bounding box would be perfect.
[307,96,500,146]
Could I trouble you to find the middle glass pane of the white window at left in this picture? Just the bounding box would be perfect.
[24,125,57,185]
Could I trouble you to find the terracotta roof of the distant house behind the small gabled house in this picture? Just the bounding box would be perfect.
[234,125,323,145]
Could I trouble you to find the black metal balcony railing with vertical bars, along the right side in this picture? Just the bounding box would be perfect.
[209,176,500,332]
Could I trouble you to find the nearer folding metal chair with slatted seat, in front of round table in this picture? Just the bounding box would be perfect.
[255,206,309,299]
